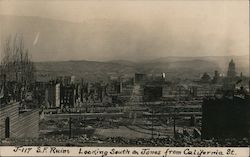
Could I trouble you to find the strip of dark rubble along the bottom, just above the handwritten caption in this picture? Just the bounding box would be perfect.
[0,135,249,147]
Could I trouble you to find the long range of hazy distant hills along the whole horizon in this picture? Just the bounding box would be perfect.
[35,56,248,81]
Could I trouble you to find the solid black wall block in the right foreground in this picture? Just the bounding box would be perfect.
[202,96,250,139]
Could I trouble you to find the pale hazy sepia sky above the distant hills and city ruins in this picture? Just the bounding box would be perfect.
[0,0,249,60]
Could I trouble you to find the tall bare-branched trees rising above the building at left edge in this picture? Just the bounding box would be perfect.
[1,35,35,85]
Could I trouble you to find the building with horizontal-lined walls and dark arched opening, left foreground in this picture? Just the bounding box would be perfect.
[0,76,39,138]
